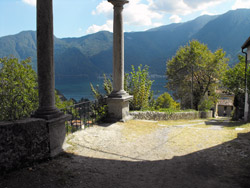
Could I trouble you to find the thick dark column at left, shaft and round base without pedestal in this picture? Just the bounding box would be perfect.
[35,0,62,120]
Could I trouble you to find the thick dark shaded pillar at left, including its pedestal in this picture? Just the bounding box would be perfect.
[34,0,71,157]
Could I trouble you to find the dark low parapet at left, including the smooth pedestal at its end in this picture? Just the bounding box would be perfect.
[0,115,70,174]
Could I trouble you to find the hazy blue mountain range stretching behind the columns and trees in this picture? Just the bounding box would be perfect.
[0,9,250,79]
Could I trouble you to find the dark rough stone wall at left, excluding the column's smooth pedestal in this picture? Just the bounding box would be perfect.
[0,119,50,173]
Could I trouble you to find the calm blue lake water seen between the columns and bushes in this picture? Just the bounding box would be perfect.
[56,77,167,101]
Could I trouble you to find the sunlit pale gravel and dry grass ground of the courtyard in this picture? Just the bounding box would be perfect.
[65,118,250,161]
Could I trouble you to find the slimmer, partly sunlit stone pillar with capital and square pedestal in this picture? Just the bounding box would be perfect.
[107,0,133,121]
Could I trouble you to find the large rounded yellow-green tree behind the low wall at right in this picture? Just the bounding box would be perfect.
[166,40,228,110]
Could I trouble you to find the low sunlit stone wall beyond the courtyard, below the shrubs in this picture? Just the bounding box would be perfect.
[130,111,212,121]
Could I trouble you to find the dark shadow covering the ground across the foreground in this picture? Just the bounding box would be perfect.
[0,133,250,188]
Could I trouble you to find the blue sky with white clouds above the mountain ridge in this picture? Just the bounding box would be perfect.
[0,0,250,38]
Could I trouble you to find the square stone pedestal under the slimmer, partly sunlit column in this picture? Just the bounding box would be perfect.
[107,95,133,122]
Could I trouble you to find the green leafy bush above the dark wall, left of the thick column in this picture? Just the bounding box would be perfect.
[0,57,38,121]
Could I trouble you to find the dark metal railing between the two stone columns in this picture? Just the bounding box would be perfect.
[66,99,106,134]
